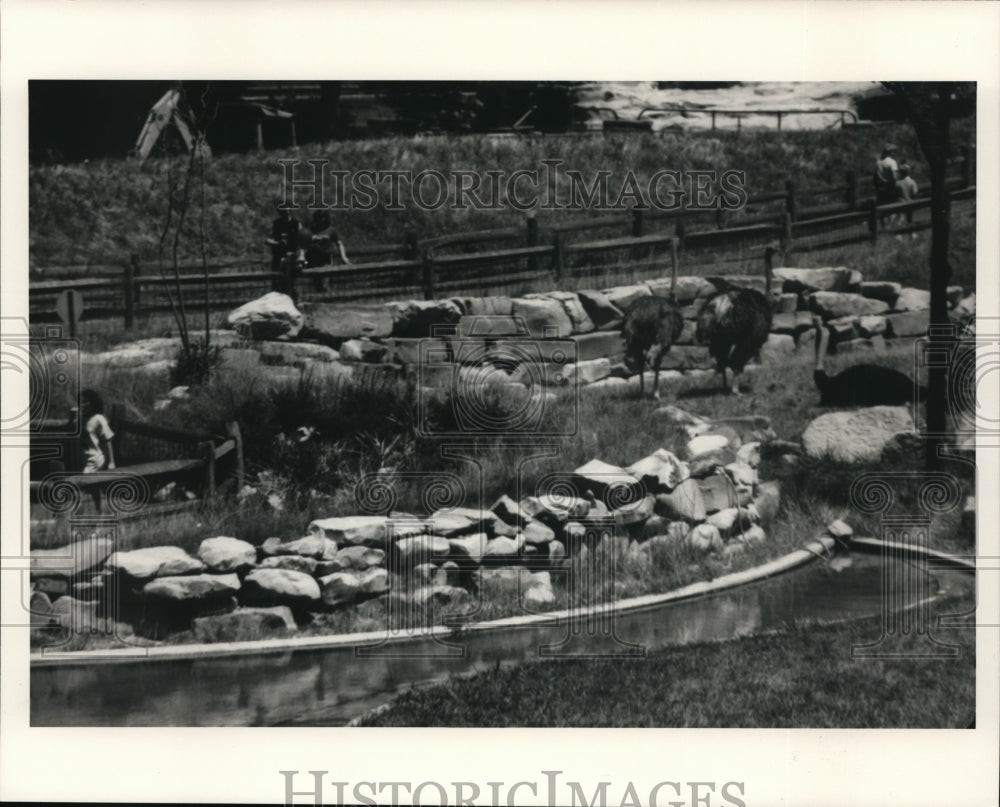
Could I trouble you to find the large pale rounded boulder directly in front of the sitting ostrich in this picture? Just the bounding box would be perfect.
[802,406,914,462]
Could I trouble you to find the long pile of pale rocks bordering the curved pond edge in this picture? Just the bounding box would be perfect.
[31,407,777,641]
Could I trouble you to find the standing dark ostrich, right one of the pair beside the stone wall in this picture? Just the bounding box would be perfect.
[695,254,772,395]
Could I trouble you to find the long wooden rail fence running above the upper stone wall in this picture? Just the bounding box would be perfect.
[29,151,976,329]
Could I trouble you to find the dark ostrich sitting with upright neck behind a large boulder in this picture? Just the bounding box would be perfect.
[813,316,927,406]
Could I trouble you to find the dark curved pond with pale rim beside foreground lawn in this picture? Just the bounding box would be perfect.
[31,552,975,726]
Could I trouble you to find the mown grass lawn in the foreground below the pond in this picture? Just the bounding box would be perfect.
[363,597,976,728]
